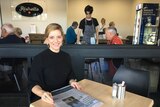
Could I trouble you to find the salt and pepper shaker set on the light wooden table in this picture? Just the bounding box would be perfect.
[112,81,126,99]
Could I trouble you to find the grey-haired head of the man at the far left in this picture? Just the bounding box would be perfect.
[1,23,14,38]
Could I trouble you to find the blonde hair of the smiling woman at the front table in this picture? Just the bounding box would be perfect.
[44,23,64,39]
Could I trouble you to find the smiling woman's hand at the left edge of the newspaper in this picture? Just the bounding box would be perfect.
[41,92,54,104]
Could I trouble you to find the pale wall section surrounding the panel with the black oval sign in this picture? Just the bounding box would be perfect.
[0,0,67,36]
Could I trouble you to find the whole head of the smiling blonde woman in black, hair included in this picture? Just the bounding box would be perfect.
[45,23,64,53]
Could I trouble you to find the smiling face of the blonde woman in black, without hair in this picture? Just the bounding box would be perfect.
[47,30,63,53]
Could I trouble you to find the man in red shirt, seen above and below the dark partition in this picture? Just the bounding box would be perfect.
[105,26,123,76]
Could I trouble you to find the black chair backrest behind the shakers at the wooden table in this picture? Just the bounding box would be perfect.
[113,65,150,97]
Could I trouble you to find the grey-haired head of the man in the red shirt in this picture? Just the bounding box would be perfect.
[105,26,117,40]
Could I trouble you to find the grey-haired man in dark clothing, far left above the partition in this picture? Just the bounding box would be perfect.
[0,23,24,44]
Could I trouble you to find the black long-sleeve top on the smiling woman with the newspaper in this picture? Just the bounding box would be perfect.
[29,49,75,100]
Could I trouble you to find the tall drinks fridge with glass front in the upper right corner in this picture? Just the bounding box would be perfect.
[133,3,160,45]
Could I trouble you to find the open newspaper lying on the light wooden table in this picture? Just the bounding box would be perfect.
[51,85,103,107]
